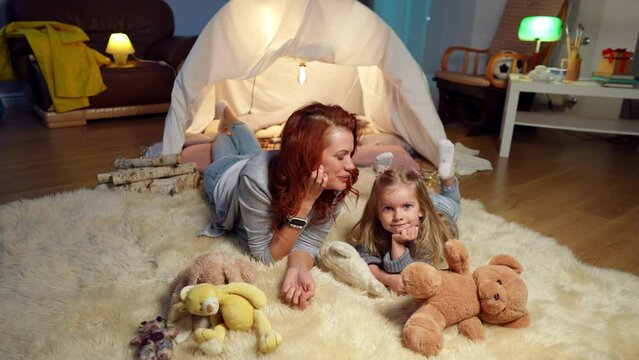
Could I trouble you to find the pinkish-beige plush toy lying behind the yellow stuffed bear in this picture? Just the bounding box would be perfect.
[168,253,256,343]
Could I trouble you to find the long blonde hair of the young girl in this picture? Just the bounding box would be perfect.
[351,167,456,262]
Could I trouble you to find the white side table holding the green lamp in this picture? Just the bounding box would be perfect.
[499,74,639,158]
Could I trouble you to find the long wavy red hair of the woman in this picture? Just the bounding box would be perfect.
[268,102,359,230]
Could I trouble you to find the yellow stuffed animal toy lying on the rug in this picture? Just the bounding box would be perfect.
[174,282,282,355]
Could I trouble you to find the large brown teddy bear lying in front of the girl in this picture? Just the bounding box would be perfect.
[401,240,530,356]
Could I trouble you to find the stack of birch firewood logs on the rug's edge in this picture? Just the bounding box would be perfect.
[97,154,200,195]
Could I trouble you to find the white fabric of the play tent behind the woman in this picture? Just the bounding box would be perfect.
[162,0,446,163]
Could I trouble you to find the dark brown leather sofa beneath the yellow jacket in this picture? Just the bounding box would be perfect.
[5,0,196,128]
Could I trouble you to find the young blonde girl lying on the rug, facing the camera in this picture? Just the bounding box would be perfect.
[351,140,461,294]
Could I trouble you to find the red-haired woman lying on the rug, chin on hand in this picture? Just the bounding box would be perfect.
[203,101,358,308]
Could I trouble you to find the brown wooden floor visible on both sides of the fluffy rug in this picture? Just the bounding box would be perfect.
[0,107,639,275]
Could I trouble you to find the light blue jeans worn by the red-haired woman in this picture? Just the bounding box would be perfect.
[204,122,262,201]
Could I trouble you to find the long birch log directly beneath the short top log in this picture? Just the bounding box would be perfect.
[98,163,197,185]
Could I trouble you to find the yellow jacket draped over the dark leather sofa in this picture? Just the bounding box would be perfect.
[0,21,110,112]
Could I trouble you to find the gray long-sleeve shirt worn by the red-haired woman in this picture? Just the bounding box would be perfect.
[202,151,342,263]
